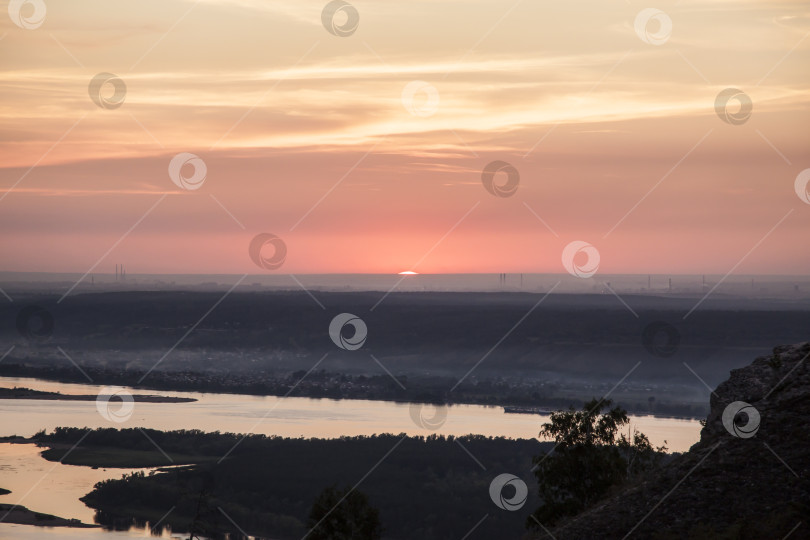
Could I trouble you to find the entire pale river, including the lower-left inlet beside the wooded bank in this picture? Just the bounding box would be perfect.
[0,377,701,540]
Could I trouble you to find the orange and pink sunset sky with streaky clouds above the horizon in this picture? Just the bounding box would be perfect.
[0,0,810,272]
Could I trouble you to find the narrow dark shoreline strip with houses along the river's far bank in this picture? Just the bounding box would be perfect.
[0,362,708,418]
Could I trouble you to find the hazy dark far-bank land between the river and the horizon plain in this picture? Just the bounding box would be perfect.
[0,291,810,416]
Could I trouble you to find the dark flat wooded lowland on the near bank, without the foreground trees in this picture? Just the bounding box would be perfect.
[36,428,550,540]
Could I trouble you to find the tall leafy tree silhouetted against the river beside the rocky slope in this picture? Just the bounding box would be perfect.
[527,399,666,528]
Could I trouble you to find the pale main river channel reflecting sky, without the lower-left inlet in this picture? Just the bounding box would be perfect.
[0,378,700,451]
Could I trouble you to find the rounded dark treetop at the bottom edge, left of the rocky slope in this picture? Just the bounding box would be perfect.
[306,486,382,540]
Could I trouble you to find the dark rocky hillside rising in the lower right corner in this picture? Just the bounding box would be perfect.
[538,343,810,540]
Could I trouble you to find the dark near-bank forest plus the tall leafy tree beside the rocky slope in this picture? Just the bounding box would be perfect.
[34,398,673,540]
